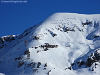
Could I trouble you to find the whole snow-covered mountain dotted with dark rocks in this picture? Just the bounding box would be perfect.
[0,13,100,75]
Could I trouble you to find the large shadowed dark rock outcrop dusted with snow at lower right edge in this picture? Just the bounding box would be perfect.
[72,49,100,71]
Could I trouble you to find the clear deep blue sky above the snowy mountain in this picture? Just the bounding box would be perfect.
[0,0,100,37]
